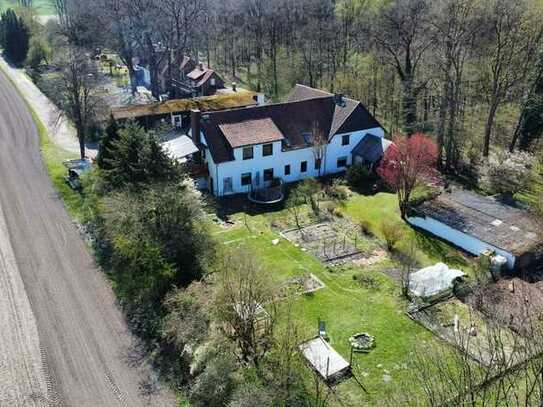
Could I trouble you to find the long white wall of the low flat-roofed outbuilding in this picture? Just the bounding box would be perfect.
[407,216,515,270]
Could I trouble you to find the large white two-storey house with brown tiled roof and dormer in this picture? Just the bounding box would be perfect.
[192,85,389,196]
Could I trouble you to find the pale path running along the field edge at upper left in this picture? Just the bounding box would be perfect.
[0,56,98,158]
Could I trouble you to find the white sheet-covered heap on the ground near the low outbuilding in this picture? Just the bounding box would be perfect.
[409,263,465,302]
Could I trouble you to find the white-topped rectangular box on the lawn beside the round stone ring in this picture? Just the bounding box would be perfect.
[299,336,352,384]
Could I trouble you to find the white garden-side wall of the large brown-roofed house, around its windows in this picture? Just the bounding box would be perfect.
[206,127,384,196]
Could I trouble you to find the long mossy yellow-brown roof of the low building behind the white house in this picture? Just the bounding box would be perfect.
[111,90,256,120]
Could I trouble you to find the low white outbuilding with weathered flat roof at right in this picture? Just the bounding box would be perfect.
[407,190,543,271]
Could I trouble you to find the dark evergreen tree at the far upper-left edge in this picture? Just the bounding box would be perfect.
[0,9,30,64]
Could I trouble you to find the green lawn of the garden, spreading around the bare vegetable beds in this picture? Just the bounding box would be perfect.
[215,193,469,406]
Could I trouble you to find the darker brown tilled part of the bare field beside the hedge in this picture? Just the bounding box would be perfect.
[0,72,175,407]
